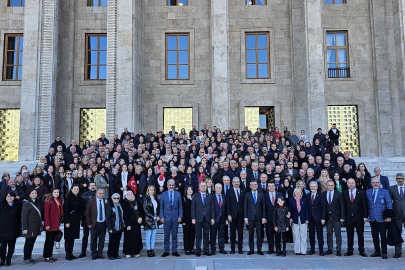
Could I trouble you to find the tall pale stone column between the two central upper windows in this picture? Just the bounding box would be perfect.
[211,0,230,129]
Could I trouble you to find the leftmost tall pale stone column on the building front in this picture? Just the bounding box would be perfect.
[18,0,42,160]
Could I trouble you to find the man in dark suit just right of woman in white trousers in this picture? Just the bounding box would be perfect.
[306,181,326,256]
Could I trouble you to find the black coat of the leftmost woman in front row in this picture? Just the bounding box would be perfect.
[0,200,22,240]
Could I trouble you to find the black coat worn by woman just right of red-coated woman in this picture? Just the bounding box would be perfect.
[63,192,84,240]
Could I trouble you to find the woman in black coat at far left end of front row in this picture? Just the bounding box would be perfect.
[0,191,22,266]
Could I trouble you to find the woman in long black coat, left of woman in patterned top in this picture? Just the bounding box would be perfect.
[122,190,143,258]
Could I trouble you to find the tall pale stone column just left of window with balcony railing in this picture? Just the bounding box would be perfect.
[305,0,328,136]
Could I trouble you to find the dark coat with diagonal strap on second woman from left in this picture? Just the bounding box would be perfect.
[21,199,42,238]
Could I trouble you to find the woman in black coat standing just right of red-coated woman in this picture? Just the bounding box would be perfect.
[63,185,84,261]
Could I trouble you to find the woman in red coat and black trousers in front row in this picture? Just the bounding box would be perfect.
[43,188,63,262]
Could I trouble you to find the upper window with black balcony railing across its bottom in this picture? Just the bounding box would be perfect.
[326,31,350,78]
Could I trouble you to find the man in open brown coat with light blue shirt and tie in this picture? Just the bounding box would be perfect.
[86,189,108,260]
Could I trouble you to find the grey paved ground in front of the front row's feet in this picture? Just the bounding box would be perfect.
[7,251,405,270]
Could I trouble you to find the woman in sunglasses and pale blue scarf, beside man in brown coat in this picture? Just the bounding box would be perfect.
[106,193,125,260]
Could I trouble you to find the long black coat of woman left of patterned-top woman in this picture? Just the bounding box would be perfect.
[121,200,144,255]
